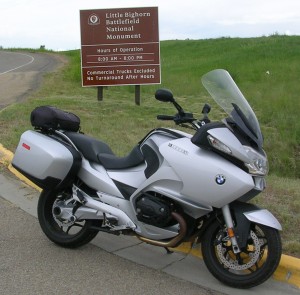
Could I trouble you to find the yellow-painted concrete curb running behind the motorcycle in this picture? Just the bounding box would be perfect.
[0,144,300,288]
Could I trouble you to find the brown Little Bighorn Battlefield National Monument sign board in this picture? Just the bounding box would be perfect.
[80,7,160,86]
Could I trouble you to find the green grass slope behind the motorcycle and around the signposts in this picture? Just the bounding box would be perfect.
[0,35,300,257]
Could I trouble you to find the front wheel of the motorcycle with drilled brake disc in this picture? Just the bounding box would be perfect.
[201,220,281,289]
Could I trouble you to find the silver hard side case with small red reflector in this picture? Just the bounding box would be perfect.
[12,130,81,189]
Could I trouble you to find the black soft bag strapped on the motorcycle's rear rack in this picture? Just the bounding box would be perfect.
[30,106,80,132]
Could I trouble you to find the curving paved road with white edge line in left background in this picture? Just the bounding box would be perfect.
[0,50,64,109]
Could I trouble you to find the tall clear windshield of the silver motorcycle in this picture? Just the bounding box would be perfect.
[201,70,263,147]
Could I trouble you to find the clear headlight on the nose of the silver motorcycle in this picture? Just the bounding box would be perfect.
[243,146,269,176]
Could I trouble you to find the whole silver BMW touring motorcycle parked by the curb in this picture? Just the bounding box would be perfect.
[12,70,282,288]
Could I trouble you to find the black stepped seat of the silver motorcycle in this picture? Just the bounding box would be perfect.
[65,132,144,170]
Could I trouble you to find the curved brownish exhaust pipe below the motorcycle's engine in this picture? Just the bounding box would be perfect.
[137,212,187,248]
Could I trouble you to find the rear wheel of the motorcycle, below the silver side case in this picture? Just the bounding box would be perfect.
[38,190,98,248]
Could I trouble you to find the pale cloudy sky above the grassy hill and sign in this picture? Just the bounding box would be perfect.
[0,0,300,51]
